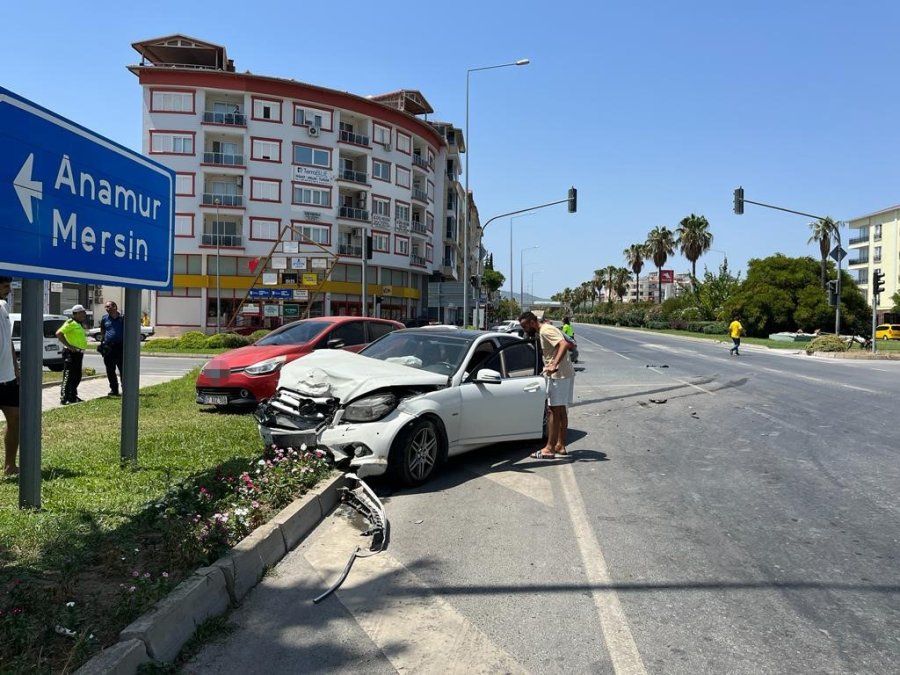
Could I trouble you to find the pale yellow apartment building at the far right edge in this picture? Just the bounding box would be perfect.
[844,206,900,323]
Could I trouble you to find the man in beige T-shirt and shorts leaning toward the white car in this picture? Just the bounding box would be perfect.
[519,312,575,459]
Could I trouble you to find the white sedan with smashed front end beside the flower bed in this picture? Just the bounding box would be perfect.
[256,326,546,486]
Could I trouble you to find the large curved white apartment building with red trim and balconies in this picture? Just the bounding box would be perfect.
[129,35,477,335]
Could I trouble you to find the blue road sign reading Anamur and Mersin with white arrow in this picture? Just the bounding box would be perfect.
[0,87,175,290]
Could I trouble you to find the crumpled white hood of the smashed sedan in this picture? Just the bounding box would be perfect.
[278,349,447,401]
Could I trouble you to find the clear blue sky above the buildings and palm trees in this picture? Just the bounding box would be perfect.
[0,0,900,296]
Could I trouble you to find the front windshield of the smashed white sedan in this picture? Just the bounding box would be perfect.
[360,331,472,374]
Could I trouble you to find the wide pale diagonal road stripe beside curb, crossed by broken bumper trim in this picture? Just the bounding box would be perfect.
[304,517,528,674]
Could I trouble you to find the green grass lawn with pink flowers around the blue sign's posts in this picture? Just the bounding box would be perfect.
[0,373,328,673]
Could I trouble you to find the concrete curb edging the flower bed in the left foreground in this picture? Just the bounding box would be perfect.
[76,474,346,675]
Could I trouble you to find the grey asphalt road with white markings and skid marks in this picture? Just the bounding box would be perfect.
[186,325,900,675]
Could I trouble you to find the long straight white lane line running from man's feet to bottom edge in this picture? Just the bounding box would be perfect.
[559,463,647,675]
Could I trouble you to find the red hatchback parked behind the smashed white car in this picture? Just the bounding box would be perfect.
[197,316,404,409]
